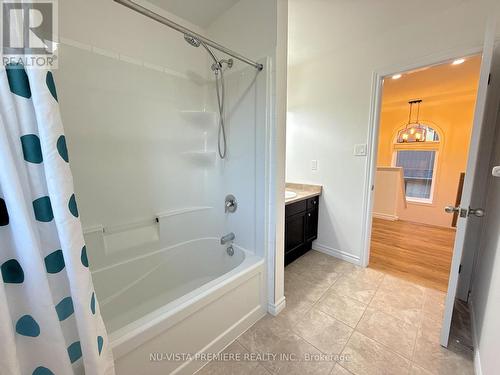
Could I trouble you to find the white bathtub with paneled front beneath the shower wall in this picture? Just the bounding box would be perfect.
[92,238,266,375]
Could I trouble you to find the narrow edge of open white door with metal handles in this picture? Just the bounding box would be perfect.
[441,21,495,347]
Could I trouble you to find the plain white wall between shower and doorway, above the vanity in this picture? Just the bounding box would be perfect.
[286,0,500,262]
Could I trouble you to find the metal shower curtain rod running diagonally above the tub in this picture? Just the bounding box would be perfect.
[114,0,264,70]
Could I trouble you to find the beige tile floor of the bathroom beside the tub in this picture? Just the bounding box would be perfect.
[198,251,474,375]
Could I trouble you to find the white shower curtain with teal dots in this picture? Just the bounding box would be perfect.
[0,64,114,375]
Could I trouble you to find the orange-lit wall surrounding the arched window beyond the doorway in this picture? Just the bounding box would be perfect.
[377,96,475,227]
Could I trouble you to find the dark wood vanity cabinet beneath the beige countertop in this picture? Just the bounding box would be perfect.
[285,197,319,265]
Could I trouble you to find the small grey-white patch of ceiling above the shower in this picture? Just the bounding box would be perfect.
[149,0,239,28]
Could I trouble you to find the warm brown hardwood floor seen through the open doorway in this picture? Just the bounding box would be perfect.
[369,218,455,292]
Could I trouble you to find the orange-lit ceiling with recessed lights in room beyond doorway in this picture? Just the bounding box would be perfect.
[383,55,481,106]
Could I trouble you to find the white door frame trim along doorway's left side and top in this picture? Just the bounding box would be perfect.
[361,45,483,267]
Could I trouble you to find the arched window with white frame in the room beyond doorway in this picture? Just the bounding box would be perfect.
[393,123,442,203]
